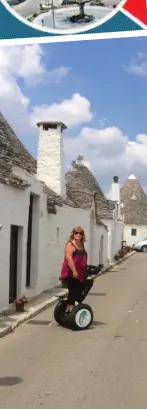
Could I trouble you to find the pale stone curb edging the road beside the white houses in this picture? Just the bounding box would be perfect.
[0,251,136,338]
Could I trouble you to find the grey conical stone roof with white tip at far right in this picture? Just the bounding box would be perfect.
[121,174,147,225]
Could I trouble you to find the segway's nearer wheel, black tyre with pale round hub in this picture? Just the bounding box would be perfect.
[70,303,93,330]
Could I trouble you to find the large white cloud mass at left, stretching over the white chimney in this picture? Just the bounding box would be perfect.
[0,44,90,135]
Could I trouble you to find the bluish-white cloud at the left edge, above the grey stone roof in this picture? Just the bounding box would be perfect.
[0,44,70,133]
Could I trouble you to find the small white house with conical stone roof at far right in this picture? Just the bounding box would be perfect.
[120,174,147,246]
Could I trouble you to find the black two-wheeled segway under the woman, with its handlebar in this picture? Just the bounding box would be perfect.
[54,265,102,330]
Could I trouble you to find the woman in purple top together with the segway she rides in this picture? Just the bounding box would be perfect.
[54,226,98,330]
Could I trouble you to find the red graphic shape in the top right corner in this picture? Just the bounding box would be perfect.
[123,0,147,25]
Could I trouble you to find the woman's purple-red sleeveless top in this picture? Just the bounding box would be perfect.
[60,242,87,282]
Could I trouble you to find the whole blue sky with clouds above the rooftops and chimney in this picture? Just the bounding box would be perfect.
[0,38,147,194]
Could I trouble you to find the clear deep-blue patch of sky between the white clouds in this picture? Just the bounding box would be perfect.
[21,35,147,139]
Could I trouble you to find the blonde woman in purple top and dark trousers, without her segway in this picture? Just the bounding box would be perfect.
[60,226,87,313]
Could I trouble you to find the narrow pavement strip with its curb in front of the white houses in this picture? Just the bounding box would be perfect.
[0,251,136,338]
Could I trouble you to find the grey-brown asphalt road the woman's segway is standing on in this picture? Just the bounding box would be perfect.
[0,254,147,409]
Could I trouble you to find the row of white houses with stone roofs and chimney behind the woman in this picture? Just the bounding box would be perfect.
[0,110,122,309]
